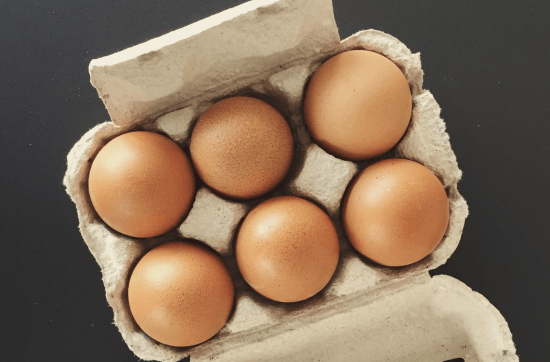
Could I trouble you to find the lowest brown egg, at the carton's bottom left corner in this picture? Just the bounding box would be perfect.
[128,241,235,347]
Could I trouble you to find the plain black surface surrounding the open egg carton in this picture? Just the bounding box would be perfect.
[0,0,550,362]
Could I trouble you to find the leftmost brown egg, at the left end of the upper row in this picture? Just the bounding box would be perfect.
[88,132,195,238]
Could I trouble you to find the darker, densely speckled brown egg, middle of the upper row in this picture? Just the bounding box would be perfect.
[190,97,293,199]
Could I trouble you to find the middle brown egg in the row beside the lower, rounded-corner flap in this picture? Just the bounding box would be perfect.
[235,196,340,302]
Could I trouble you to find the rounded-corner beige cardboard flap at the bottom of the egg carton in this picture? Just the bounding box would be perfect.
[192,275,518,362]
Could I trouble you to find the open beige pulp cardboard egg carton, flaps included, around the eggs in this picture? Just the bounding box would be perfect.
[63,0,518,362]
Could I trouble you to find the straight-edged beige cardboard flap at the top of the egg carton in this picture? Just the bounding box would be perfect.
[89,0,340,125]
